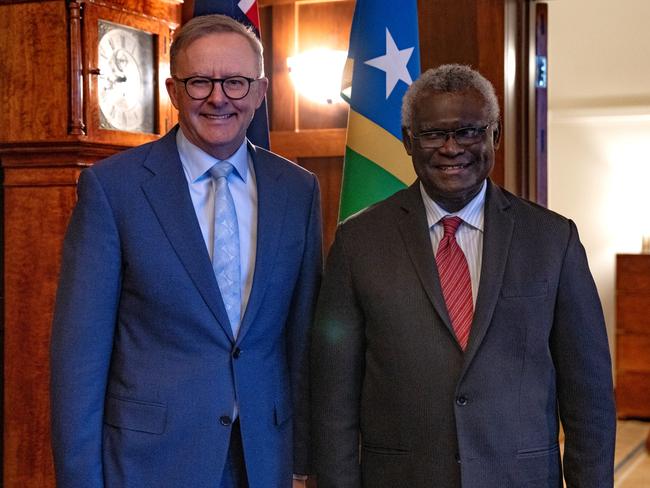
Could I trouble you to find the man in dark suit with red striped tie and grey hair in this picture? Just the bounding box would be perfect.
[311,65,615,488]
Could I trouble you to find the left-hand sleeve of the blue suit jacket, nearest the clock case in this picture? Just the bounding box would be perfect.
[50,169,121,488]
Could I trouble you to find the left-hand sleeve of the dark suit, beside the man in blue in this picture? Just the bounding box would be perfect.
[311,228,365,488]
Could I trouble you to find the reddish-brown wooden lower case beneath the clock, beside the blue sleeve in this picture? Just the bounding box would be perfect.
[3,153,78,487]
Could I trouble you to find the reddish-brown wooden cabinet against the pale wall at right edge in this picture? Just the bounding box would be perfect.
[616,254,650,418]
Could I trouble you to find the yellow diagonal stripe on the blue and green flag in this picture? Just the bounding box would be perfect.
[347,110,416,185]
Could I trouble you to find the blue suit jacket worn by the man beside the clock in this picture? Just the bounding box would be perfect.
[51,130,322,488]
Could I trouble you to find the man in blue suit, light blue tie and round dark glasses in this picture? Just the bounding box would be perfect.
[51,16,322,488]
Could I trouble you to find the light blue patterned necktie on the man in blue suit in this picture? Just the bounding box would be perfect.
[210,161,241,337]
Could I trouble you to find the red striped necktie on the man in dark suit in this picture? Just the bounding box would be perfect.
[436,217,474,351]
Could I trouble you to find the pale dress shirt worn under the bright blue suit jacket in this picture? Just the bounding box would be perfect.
[176,128,257,318]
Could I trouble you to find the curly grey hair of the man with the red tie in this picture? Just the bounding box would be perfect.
[402,64,499,129]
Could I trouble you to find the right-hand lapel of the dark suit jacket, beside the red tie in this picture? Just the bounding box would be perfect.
[465,180,514,368]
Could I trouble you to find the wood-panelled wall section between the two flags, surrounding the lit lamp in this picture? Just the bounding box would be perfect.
[260,0,355,249]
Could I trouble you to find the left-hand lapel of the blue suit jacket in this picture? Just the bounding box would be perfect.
[142,130,234,340]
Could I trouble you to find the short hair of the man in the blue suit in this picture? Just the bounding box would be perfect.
[169,14,264,76]
